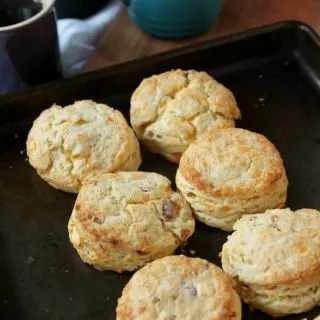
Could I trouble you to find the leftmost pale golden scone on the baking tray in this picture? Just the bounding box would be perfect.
[27,100,141,193]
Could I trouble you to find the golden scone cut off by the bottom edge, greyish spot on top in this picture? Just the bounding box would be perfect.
[117,255,241,320]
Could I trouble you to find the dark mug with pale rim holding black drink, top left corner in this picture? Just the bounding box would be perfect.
[0,0,61,94]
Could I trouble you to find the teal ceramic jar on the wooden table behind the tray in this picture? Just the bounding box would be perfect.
[124,0,221,38]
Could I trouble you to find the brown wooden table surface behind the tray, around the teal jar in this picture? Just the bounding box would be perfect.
[84,0,320,71]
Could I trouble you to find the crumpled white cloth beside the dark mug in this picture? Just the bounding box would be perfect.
[58,0,121,77]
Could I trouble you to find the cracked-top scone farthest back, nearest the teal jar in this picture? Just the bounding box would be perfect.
[130,69,240,163]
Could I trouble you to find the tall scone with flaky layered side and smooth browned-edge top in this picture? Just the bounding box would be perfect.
[176,128,288,231]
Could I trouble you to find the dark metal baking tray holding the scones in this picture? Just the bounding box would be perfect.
[0,21,320,320]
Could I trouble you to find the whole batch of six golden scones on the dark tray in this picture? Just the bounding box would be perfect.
[27,69,320,320]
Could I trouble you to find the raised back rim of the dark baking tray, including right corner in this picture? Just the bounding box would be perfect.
[0,20,320,108]
